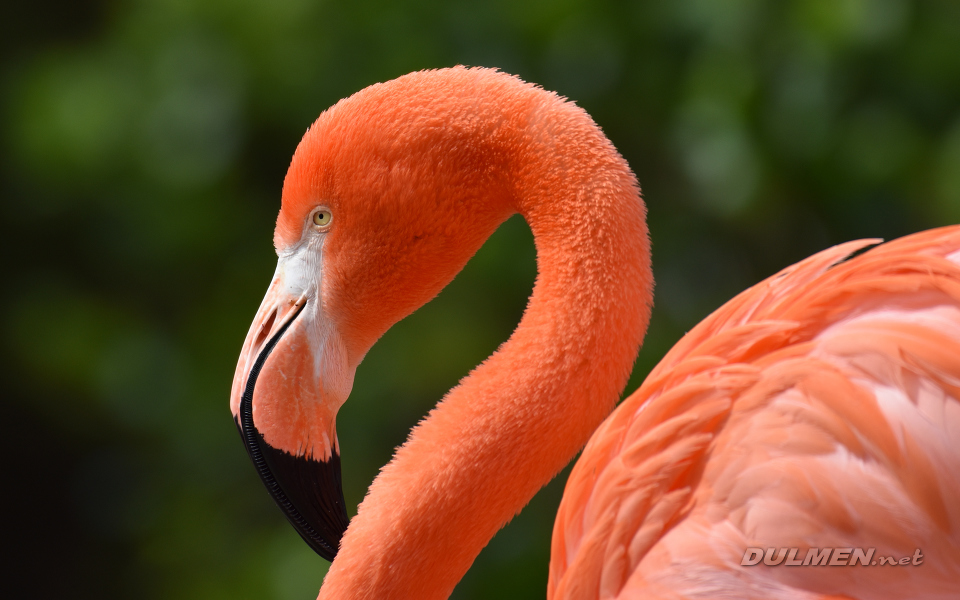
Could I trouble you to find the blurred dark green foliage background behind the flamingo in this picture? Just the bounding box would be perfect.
[0,0,960,600]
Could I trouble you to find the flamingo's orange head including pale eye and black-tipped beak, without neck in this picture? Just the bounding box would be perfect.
[230,69,516,560]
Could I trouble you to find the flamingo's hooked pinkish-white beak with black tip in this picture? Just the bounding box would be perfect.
[230,249,353,561]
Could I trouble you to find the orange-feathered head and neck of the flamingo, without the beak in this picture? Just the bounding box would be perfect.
[277,68,653,600]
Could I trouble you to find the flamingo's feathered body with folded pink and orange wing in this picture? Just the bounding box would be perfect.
[549,227,960,600]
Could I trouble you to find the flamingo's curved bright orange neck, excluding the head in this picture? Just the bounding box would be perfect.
[320,88,652,600]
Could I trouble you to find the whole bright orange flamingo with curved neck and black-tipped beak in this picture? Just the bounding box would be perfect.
[231,67,960,600]
